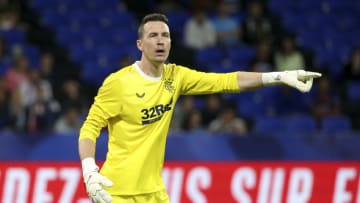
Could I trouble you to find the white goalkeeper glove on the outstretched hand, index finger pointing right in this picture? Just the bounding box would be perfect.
[262,70,321,92]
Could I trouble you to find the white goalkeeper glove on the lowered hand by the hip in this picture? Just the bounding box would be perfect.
[81,157,113,203]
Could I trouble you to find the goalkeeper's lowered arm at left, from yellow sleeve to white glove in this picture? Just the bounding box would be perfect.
[78,75,120,203]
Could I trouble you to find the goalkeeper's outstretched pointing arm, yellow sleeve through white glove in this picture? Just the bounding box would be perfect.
[177,67,321,95]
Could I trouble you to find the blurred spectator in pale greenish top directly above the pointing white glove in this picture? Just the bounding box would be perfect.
[274,35,305,71]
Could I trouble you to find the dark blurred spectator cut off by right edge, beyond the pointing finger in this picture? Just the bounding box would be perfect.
[343,48,360,81]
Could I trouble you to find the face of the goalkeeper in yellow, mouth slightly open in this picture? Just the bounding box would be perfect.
[137,21,171,63]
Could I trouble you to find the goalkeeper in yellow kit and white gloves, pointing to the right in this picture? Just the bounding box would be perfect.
[79,13,321,203]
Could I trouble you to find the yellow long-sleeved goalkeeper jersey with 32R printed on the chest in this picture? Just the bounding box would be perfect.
[79,63,239,195]
